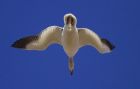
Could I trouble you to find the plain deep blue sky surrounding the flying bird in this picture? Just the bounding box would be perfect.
[0,0,140,89]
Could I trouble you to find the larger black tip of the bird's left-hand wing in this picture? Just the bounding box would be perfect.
[11,36,38,49]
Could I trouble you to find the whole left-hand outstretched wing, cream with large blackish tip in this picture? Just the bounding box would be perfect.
[12,26,63,50]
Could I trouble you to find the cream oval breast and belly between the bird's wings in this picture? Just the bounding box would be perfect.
[62,30,79,56]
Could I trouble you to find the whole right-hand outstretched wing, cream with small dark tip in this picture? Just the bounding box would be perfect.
[78,28,115,53]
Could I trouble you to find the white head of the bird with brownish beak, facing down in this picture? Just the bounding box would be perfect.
[64,13,77,26]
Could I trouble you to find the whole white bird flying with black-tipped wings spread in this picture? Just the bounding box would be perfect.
[12,13,115,75]
